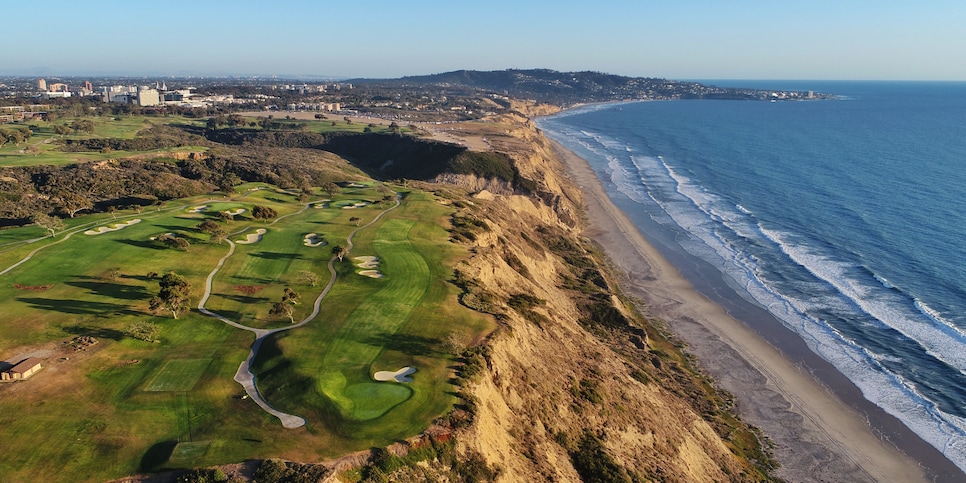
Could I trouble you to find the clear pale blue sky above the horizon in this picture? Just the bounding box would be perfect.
[0,0,966,80]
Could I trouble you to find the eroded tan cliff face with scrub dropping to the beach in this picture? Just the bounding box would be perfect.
[450,118,780,482]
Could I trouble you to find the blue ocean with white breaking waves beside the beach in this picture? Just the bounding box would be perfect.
[537,81,966,470]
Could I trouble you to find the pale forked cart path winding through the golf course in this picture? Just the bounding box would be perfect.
[198,193,400,429]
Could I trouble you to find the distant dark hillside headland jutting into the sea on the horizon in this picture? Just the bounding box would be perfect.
[351,69,824,105]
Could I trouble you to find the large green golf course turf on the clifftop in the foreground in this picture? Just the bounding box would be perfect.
[0,185,490,481]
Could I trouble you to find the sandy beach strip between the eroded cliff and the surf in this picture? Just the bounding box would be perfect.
[548,137,963,481]
